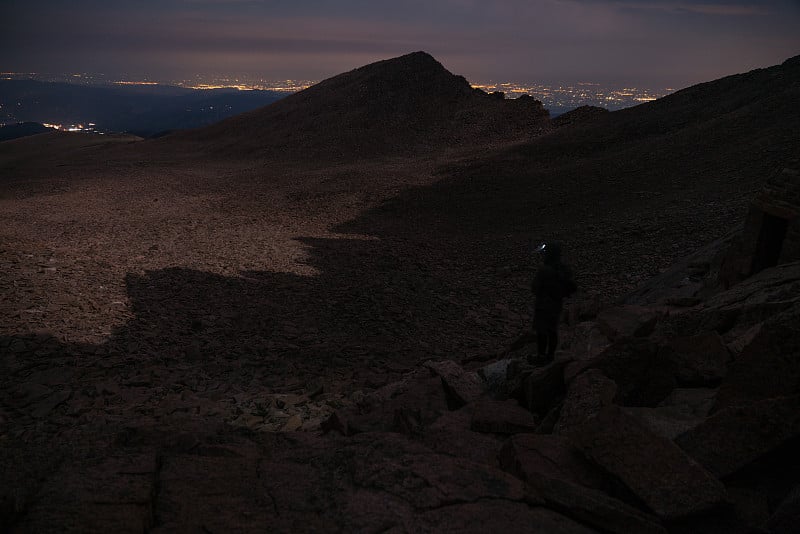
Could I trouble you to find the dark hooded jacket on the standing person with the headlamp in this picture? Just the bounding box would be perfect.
[531,243,576,327]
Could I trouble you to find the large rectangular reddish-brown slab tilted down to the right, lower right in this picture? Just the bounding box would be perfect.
[572,406,728,521]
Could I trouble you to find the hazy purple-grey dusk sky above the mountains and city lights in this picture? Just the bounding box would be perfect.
[0,0,800,89]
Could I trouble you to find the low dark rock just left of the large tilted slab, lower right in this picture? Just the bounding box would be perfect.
[497,434,606,489]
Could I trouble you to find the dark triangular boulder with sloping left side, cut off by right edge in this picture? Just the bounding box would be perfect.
[714,305,800,410]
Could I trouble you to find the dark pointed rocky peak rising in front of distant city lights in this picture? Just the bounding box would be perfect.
[177,52,548,159]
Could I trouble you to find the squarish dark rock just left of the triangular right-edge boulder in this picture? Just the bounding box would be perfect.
[669,332,731,387]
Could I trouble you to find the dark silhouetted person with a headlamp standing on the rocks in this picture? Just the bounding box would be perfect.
[531,242,577,363]
